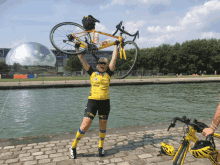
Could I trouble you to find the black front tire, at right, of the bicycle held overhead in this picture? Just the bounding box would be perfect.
[114,41,139,79]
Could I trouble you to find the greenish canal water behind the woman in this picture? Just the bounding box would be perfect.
[0,83,220,139]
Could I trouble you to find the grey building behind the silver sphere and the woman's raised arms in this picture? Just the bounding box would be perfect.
[0,48,112,72]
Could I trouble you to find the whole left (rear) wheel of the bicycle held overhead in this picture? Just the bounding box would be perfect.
[50,22,91,55]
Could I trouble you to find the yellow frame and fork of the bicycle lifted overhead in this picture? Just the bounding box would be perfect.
[72,29,126,60]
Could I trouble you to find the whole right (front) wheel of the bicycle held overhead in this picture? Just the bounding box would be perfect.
[114,41,138,79]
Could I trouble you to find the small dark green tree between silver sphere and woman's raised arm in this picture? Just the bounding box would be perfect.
[64,56,82,76]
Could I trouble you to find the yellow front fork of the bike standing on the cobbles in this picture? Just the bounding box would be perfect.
[173,139,189,165]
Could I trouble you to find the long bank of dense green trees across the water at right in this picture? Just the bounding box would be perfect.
[127,38,220,74]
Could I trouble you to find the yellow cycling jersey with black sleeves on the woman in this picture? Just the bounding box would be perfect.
[88,66,113,100]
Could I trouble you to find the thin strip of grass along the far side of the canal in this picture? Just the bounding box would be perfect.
[0,75,220,82]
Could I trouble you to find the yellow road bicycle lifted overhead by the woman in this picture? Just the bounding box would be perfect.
[50,18,139,79]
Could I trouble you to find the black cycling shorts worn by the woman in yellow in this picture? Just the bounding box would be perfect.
[84,99,110,120]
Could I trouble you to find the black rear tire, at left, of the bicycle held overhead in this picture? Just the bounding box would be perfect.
[50,22,91,55]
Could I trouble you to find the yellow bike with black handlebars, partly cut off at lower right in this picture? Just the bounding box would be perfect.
[167,116,220,165]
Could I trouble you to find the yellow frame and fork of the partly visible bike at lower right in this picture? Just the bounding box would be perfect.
[173,127,220,165]
